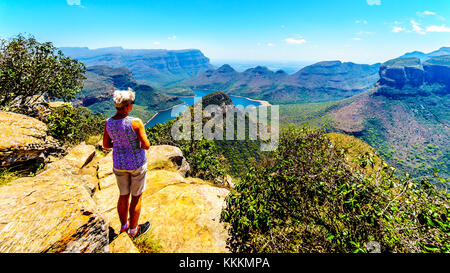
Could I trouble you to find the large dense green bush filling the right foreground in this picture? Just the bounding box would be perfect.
[222,127,450,253]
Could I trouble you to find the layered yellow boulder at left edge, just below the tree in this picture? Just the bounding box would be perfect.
[0,112,59,166]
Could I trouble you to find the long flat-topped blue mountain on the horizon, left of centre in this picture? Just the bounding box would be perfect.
[61,47,212,86]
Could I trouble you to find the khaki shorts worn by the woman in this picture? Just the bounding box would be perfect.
[113,163,147,196]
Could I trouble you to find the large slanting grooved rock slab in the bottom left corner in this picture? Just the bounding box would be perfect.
[0,144,108,253]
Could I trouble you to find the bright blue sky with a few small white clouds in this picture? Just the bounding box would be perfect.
[0,0,450,63]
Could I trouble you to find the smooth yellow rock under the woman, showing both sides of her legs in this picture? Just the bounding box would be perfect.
[94,145,229,252]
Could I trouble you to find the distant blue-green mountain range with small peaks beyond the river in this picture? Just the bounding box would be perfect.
[179,61,379,103]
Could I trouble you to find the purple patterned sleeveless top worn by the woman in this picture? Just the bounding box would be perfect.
[106,117,147,171]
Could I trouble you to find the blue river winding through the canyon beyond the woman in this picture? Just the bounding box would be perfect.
[145,90,262,128]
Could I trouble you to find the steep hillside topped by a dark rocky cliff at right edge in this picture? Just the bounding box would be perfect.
[280,56,450,177]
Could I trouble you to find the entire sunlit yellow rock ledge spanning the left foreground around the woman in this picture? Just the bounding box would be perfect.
[0,112,229,253]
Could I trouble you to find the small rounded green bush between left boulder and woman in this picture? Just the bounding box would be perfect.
[46,105,105,144]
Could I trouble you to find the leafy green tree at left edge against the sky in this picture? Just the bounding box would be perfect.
[0,34,86,107]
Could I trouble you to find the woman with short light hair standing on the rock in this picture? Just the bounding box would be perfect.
[103,90,150,238]
